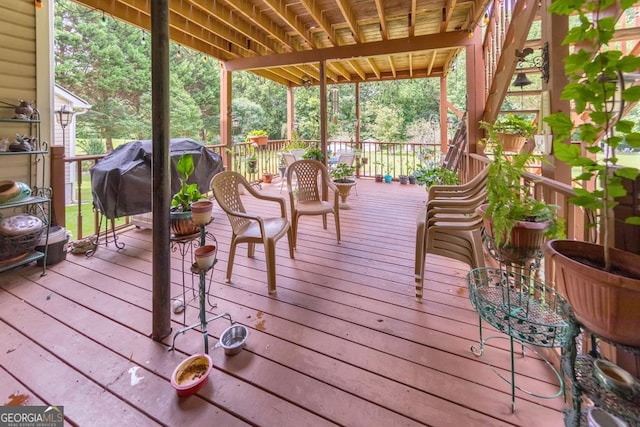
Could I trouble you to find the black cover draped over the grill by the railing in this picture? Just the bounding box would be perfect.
[90,139,222,219]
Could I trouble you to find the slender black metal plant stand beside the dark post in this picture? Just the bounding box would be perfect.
[168,225,234,354]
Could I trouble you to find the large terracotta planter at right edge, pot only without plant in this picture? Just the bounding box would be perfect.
[545,240,640,347]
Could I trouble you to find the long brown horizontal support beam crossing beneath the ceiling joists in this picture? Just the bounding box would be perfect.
[226,30,470,71]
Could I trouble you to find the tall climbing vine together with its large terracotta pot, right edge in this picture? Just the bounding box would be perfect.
[544,0,640,346]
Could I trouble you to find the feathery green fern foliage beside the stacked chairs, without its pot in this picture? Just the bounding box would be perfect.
[480,122,563,246]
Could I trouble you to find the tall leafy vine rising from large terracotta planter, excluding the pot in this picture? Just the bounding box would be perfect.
[544,0,640,271]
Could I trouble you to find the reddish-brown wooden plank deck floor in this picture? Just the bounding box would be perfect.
[0,179,563,427]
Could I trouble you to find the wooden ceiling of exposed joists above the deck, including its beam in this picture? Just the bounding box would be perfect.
[74,0,487,86]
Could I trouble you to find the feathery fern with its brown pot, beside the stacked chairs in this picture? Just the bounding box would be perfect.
[479,122,563,266]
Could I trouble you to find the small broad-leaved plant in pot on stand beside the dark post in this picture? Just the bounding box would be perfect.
[170,154,205,236]
